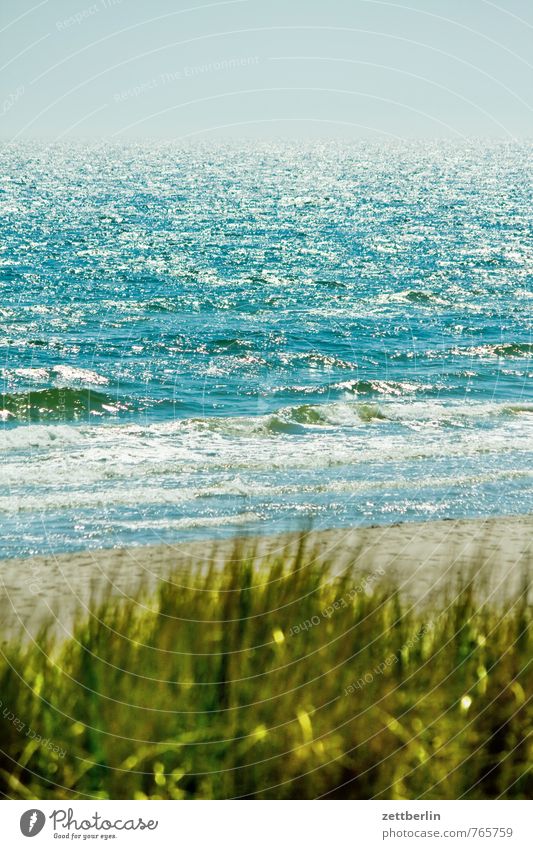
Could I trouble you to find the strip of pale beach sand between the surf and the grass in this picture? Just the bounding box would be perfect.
[0,515,533,642]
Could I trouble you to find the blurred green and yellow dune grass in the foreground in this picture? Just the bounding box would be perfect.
[0,550,533,799]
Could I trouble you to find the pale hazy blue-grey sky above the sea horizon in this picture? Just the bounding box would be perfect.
[0,0,533,142]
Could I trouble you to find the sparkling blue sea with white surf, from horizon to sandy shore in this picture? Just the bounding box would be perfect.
[0,141,533,556]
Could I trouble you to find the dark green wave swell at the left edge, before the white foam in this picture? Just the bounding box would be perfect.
[0,386,128,422]
